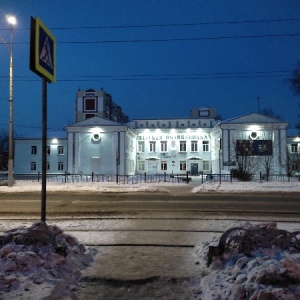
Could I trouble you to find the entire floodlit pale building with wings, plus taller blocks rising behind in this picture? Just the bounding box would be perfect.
[14,89,300,175]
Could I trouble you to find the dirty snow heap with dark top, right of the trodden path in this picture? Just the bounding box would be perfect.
[196,223,300,300]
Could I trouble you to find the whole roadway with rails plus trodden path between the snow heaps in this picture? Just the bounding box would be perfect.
[0,186,300,300]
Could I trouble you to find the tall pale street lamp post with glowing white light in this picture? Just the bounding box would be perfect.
[7,16,17,186]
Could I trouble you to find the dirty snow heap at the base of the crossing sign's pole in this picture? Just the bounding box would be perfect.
[0,222,93,299]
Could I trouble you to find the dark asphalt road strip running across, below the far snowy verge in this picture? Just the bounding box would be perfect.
[0,188,300,217]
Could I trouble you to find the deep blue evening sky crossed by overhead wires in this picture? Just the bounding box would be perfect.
[0,0,300,134]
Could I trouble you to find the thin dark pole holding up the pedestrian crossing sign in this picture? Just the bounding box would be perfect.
[41,77,47,223]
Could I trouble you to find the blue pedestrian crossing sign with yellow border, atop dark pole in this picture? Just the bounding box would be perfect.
[30,17,56,82]
